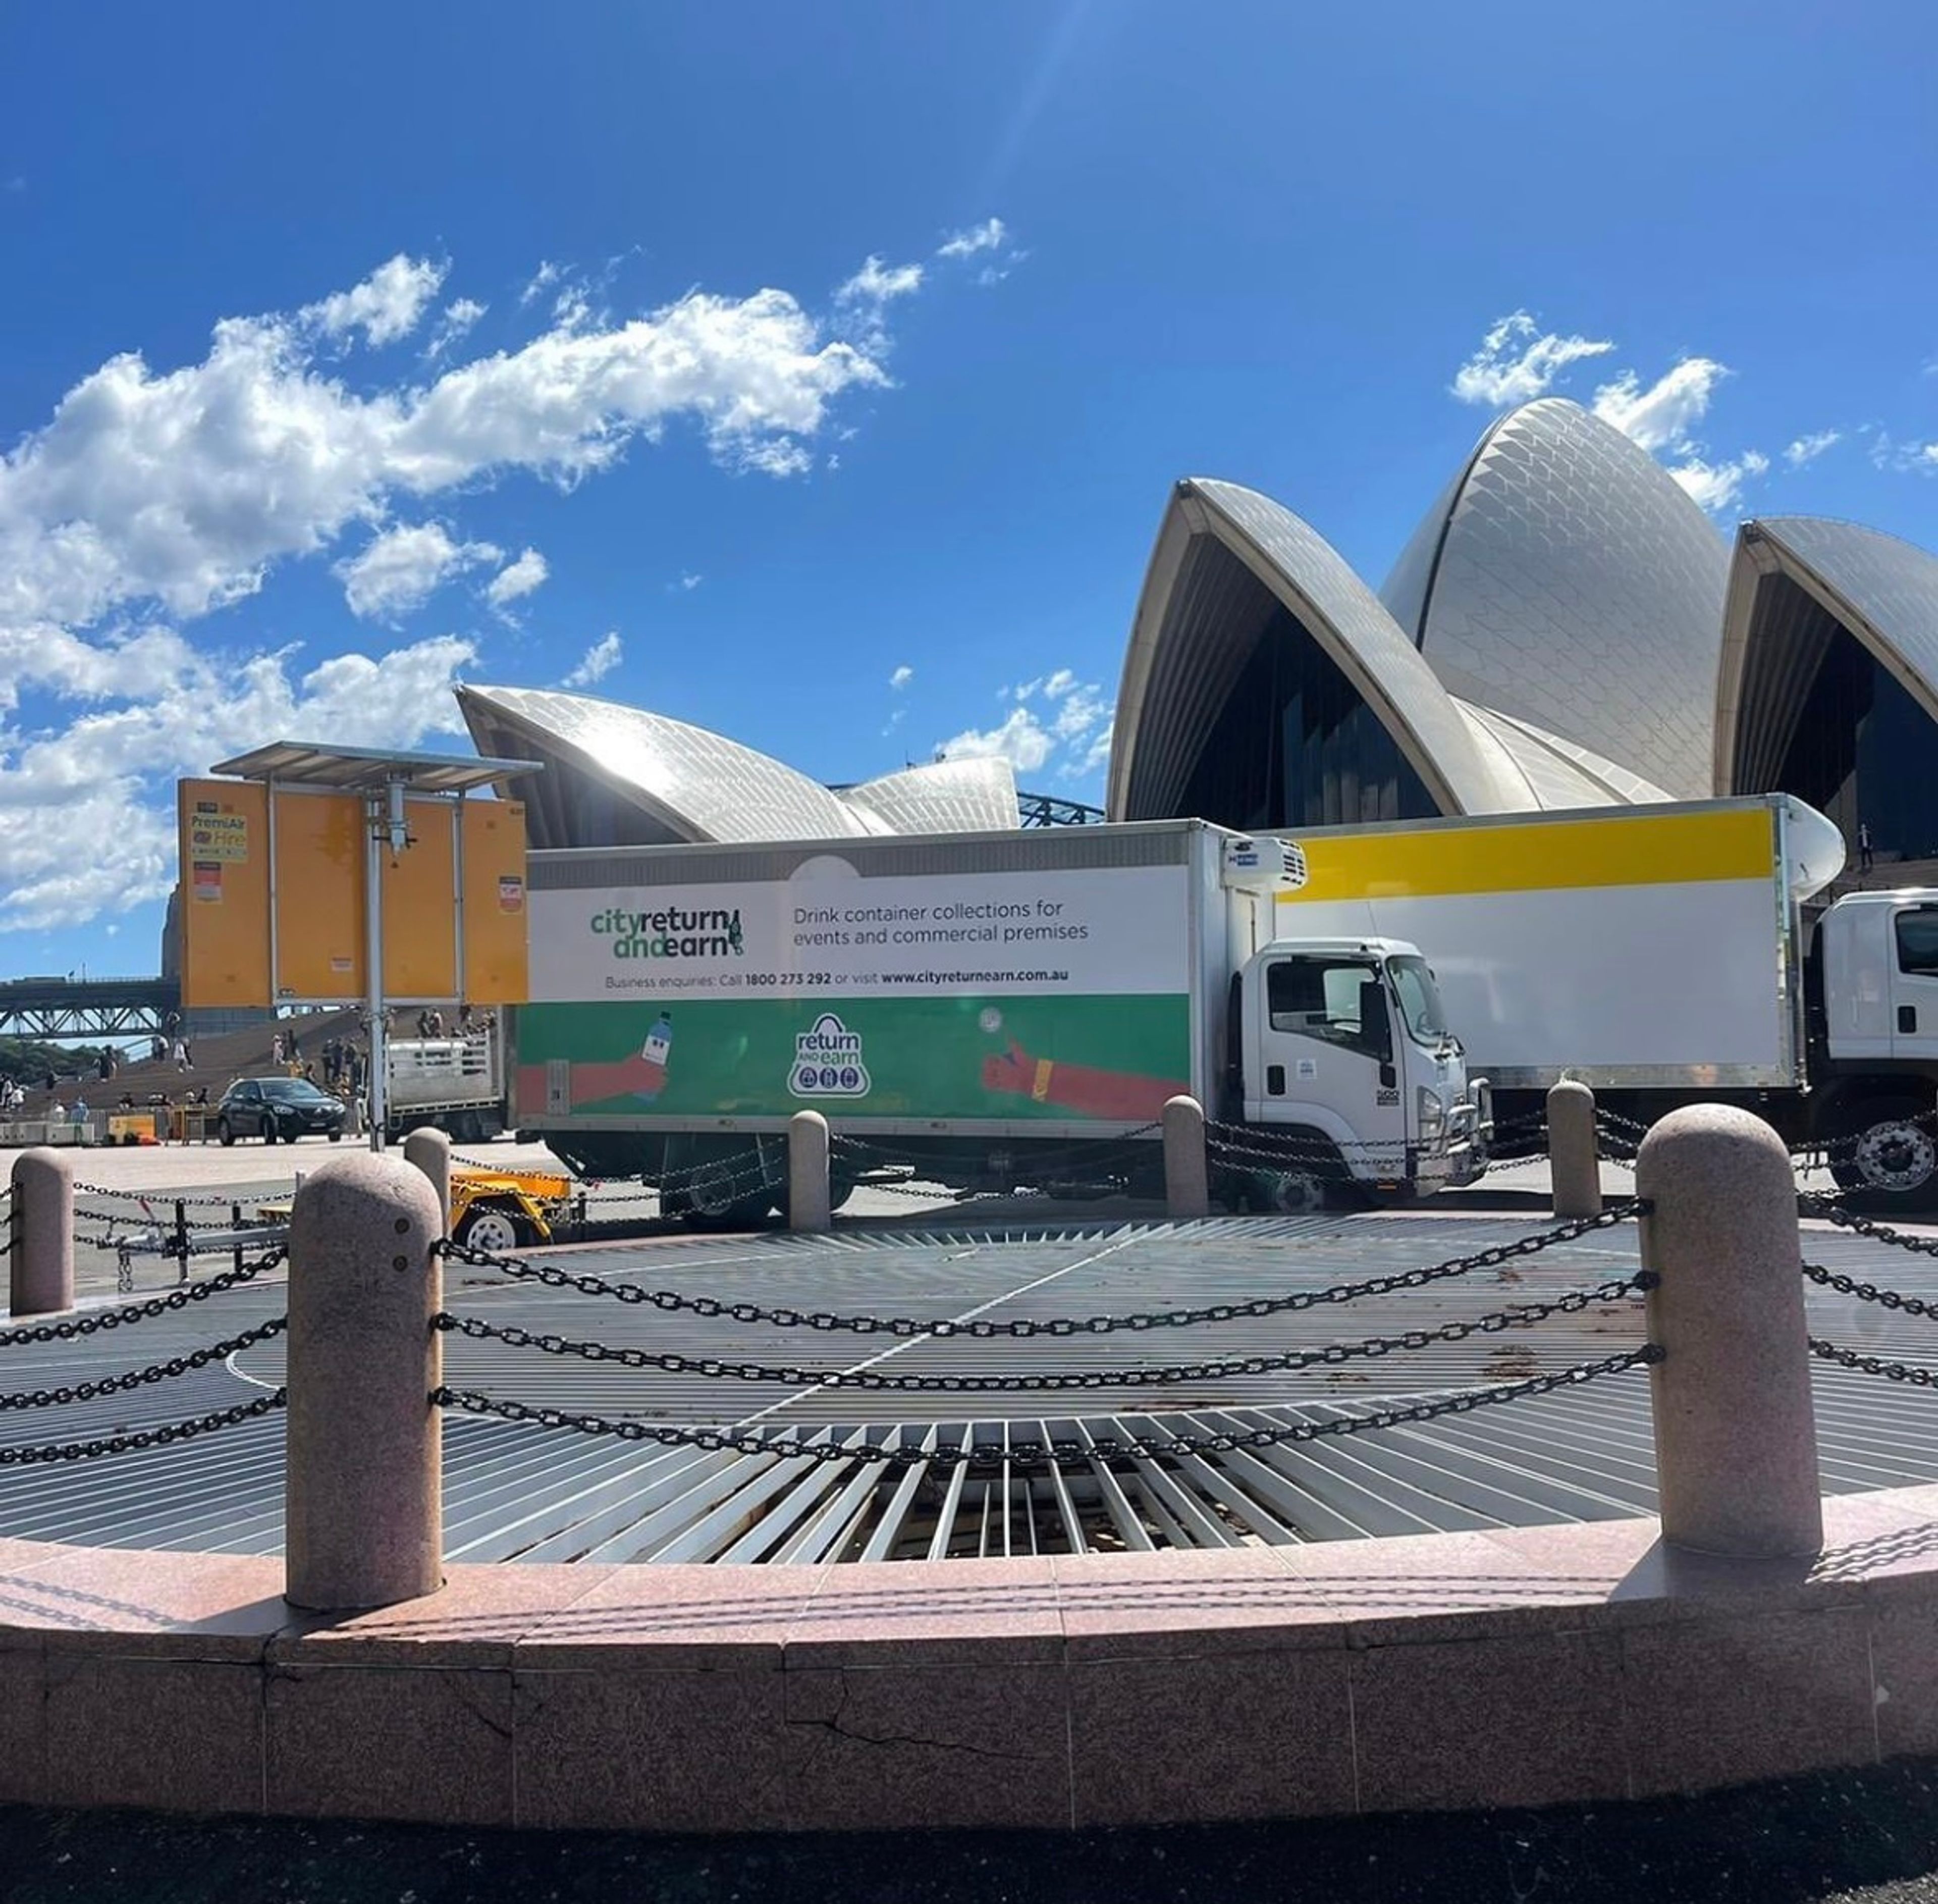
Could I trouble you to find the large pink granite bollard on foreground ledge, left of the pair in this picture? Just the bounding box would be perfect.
[283,1155,444,1611]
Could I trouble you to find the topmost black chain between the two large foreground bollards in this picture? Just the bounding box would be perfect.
[438,1198,1647,1342]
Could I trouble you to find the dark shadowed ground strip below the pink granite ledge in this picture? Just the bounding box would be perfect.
[11,1763,1938,1904]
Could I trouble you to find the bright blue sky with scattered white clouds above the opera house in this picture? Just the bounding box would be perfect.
[0,0,1938,977]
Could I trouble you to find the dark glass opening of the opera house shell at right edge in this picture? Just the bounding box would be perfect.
[1777,628,1938,859]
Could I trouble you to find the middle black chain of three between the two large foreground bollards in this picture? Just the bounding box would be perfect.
[432,1274,1655,1394]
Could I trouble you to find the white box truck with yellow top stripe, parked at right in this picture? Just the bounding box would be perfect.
[1275,795,1938,1208]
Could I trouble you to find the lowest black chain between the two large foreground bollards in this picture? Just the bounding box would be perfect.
[430,1344,1663,1468]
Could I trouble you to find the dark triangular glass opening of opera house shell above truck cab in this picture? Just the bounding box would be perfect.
[1176,605,1440,830]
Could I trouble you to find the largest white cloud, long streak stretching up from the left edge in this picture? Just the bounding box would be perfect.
[0,266,886,624]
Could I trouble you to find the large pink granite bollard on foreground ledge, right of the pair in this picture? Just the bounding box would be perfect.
[1636,1103,1823,1559]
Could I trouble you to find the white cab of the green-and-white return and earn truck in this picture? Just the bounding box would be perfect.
[1227,938,1488,1208]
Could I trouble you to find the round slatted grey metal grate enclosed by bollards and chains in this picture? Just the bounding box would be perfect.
[0,1215,1938,1565]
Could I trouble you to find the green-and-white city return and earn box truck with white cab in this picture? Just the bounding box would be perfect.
[514,820,1481,1220]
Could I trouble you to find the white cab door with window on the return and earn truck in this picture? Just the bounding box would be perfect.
[1246,952,1407,1177]
